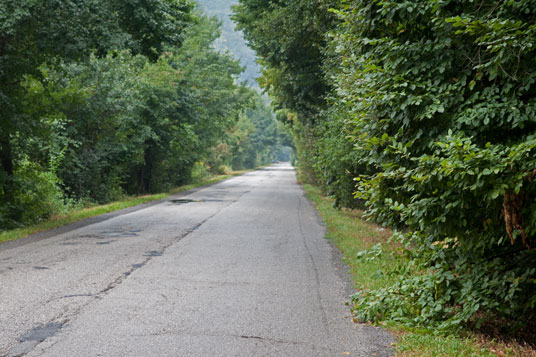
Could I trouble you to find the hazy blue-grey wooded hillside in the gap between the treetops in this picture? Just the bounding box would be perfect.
[197,0,260,88]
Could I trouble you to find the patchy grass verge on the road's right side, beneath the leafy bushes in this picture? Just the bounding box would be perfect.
[304,184,528,356]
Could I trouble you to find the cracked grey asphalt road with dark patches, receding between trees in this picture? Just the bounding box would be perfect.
[0,164,392,356]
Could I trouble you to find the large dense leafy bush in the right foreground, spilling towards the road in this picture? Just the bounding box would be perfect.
[334,0,536,328]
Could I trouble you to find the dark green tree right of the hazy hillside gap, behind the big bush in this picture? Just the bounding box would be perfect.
[233,0,336,117]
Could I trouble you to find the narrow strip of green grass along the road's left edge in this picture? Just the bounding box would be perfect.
[0,170,250,243]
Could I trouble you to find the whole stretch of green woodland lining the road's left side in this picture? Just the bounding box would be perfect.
[0,0,289,233]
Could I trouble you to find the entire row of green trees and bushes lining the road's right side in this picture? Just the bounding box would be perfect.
[234,0,536,329]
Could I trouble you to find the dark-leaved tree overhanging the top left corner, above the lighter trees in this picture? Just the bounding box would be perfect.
[0,0,192,227]
